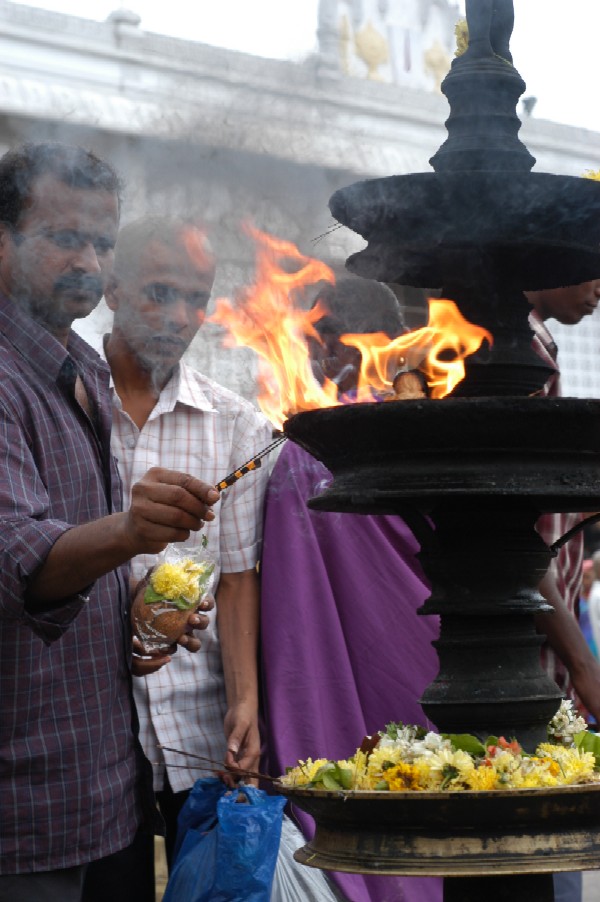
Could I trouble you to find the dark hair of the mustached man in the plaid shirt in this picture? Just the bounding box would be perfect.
[0,142,122,226]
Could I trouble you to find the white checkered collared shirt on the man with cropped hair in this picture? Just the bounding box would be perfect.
[111,363,273,792]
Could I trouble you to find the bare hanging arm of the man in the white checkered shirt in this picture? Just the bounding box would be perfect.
[216,570,260,770]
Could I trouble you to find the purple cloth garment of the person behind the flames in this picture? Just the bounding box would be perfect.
[261,442,442,902]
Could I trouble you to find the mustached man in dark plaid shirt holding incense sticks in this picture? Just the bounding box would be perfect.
[0,143,218,902]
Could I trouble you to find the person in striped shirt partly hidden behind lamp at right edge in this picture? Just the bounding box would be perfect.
[526,279,600,902]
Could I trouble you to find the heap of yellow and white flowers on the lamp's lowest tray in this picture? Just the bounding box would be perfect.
[281,701,600,792]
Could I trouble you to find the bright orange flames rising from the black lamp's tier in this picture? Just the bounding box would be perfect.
[209,227,492,428]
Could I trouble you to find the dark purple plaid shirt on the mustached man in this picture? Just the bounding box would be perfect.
[0,297,141,875]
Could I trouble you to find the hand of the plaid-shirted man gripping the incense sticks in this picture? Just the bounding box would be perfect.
[123,467,219,557]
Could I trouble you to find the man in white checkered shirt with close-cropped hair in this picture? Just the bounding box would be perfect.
[104,218,272,892]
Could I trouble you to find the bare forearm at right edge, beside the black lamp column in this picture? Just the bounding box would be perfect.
[536,573,600,721]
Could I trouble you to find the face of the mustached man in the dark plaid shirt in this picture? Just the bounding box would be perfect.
[0,175,119,333]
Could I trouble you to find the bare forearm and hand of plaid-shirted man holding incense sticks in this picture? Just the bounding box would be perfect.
[27,467,219,610]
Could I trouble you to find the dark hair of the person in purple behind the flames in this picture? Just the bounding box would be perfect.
[315,277,406,338]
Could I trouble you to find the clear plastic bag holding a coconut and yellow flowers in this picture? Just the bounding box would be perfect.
[131,540,215,654]
